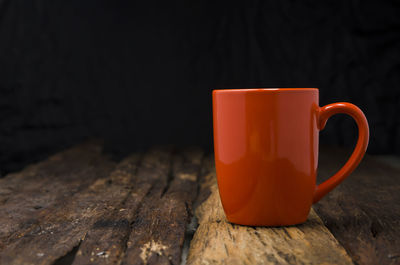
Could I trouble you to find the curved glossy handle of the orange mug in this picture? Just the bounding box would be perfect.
[313,102,369,203]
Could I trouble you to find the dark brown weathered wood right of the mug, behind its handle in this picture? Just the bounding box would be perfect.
[315,149,400,264]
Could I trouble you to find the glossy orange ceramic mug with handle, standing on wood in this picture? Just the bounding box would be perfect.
[213,88,369,226]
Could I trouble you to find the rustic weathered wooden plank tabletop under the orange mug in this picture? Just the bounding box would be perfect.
[0,142,400,265]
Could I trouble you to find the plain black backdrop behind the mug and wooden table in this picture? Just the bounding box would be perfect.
[0,0,400,174]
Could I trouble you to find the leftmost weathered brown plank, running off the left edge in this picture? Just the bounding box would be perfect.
[0,142,114,251]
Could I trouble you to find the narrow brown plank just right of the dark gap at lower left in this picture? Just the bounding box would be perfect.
[73,153,143,264]
